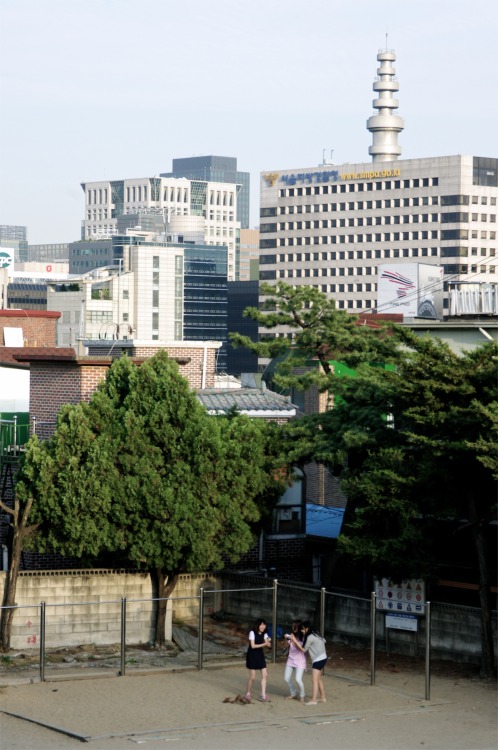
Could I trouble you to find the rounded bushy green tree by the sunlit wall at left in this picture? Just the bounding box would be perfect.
[9,352,280,643]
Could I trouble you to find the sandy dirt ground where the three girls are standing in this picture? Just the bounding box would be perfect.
[0,621,498,750]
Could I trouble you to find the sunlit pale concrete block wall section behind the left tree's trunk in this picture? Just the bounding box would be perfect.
[0,570,220,649]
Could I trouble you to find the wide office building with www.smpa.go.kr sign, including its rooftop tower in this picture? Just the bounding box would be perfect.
[260,51,498,313]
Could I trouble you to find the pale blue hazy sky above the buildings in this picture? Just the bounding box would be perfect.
[0,0,498,244]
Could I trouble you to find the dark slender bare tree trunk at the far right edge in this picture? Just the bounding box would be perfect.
[469,496,496,678]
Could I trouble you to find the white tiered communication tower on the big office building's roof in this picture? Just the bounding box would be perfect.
[367,51,405,162]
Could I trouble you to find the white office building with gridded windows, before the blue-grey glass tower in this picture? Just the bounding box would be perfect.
[82,177,240,280]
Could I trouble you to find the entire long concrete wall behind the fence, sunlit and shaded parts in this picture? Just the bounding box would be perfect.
[0,570,498,663]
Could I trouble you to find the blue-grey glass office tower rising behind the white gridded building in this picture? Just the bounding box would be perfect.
[161,156,251,229]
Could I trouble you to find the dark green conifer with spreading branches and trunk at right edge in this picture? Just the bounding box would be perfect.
[315,329,498,676]
